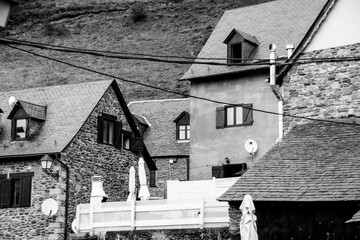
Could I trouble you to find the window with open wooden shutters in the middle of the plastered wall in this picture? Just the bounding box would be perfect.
[216,104,254,128]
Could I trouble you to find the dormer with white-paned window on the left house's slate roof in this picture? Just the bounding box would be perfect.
[8,101,46,141]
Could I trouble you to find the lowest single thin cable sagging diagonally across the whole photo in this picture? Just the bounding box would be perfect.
[4,44,360,126]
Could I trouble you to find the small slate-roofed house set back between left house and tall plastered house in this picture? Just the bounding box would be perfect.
[128,98,190,198]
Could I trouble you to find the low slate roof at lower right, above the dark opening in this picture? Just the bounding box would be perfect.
[219,122,360,201]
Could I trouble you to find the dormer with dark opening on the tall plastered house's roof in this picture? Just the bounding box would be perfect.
[224,29,259,65]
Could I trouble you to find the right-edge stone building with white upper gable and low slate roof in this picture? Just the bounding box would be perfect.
[220,0,360,239]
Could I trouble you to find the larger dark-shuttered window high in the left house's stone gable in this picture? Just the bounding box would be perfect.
[97,113,122,148]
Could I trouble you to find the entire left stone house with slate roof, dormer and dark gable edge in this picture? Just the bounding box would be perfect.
[0,81,156,240]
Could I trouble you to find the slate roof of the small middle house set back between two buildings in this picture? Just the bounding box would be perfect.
[128,98,190,156]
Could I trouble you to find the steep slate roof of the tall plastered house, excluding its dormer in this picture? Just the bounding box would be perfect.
[182,0,327,79]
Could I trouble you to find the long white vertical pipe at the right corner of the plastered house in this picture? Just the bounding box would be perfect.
[269,44,284,141]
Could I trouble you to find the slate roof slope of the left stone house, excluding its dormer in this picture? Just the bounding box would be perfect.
[0,81,112,157]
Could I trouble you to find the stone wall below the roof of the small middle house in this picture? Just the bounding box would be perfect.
[150,157,189,198]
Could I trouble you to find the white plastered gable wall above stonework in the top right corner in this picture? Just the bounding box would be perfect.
[305,0,360,52]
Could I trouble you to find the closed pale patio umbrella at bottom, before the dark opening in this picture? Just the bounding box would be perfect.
[240,194,258,240]
